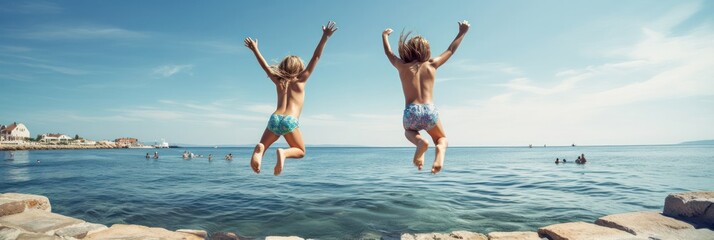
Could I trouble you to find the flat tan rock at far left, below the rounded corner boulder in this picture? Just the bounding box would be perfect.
[0,209,84,234]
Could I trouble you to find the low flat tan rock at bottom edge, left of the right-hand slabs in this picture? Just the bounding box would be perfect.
[538,222,642,240]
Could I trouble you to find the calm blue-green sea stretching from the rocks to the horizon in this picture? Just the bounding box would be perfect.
[0,145,714,239]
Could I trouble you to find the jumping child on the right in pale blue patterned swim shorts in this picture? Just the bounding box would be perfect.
[382,20,471,174]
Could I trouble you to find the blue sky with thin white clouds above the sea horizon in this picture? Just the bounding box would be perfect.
[0,1,714,146]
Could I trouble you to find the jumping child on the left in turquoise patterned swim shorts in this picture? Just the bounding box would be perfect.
[244,21,337,176]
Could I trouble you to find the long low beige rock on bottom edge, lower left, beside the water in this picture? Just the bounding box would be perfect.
[83,224,203,240]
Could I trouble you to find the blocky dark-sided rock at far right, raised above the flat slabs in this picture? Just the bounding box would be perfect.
[663,192,714,228]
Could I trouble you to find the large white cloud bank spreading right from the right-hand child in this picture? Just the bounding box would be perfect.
[441,5,714,145]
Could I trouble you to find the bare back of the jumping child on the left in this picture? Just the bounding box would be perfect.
[271,77,307,118]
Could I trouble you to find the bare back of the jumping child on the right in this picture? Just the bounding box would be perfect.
[395,60,436,105]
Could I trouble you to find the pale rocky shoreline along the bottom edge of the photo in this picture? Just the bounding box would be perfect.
[0,192,714,240]
